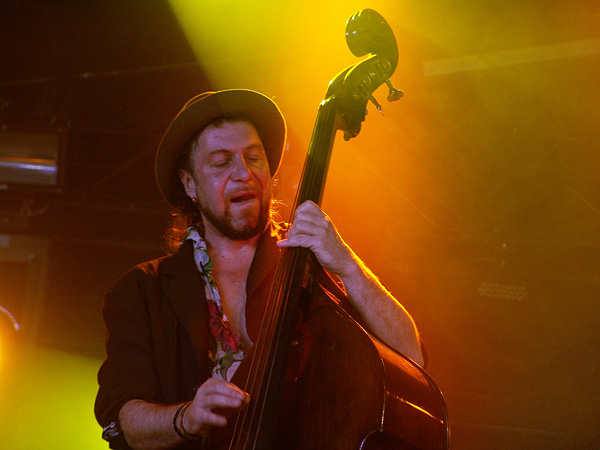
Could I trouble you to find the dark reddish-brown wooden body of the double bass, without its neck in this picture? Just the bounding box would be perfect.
[275,270,449,450]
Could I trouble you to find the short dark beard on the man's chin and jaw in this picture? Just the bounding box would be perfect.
[198,194,271,241]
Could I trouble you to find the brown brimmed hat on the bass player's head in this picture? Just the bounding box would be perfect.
[155,89,287,206]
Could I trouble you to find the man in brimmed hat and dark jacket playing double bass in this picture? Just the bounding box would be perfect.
[96,90,423,449]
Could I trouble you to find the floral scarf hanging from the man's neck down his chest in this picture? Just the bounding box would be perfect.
[182,227,246,381]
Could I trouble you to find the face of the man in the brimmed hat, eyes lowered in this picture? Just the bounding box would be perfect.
[179,118,272,240]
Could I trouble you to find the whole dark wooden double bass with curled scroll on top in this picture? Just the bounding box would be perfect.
[211,9,449,450]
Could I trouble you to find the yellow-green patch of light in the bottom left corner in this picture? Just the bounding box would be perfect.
[0,340,108,450]
